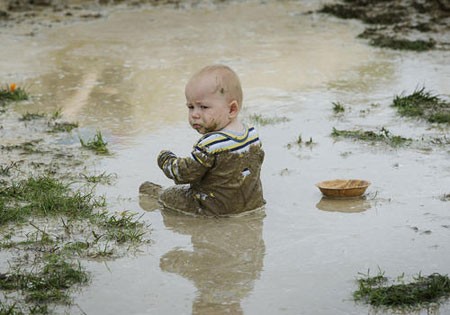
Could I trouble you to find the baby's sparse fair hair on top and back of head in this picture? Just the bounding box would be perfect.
[193,64,243,108]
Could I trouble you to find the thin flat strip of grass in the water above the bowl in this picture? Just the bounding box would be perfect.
[331,127,412,146]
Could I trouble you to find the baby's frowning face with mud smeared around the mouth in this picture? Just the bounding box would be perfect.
[185,76,231,134]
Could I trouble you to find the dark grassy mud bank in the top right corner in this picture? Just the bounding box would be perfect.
[319,0,450,51]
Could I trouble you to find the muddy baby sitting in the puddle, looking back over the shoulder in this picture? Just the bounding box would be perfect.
[158,65,265,216]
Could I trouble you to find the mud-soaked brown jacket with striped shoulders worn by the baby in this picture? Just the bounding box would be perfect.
[158,127,265,215]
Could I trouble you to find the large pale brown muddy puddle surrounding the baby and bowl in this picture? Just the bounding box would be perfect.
[0,1,450,314]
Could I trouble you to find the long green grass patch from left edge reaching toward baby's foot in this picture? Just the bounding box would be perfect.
[0,176,146,243]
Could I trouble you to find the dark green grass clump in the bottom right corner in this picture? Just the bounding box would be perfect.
[353,272,450,307]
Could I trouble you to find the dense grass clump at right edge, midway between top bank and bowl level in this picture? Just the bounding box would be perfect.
[392,87,450,123]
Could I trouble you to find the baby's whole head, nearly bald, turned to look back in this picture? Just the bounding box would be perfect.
[185,65,242,134]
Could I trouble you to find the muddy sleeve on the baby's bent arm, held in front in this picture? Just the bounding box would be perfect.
[158,148,215,184]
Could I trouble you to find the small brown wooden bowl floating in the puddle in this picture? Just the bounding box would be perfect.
[316,179,370,198]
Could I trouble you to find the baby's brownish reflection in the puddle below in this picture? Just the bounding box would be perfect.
[160,211,265,314]
